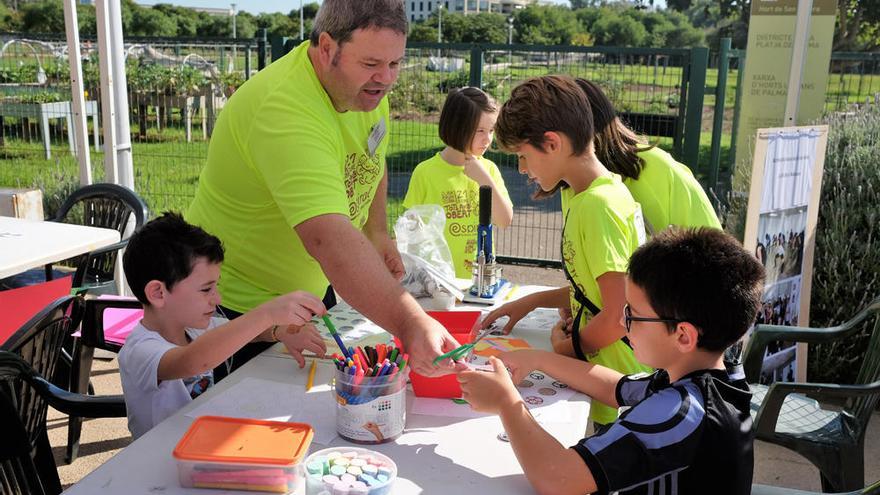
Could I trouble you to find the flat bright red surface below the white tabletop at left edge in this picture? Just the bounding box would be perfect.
[0,276,73,345]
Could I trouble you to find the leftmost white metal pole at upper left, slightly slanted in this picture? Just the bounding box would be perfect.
[64,0,97,186]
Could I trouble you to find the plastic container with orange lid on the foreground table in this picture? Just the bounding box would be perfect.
[173,416,315,495]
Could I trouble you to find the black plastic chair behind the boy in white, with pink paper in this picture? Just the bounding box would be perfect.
[65,298,142,463]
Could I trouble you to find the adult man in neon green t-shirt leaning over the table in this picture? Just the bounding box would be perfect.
[186,0,458,374]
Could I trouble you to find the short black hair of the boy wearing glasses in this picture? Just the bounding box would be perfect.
[628,227,764,352]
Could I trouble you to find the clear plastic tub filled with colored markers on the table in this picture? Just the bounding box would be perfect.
[333,344,409,444]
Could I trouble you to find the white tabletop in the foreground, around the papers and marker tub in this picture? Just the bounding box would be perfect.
[65,288,589,495]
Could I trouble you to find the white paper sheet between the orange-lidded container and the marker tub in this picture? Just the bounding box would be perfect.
[186,378,336,445]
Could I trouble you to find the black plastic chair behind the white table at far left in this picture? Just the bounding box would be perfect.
[45,183,148,288]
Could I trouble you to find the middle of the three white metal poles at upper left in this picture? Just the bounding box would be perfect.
[95,0,119,184]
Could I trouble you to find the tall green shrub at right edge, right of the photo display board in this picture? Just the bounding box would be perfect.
[808,104,880,383]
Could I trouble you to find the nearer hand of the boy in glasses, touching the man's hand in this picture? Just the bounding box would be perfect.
[458,357,522,414]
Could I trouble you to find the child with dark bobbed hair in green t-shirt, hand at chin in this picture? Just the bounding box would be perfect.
[403,88,513,278]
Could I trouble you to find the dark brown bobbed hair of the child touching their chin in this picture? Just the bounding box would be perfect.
[439,87,498,153]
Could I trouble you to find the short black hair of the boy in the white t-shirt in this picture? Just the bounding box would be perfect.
[122,212,223,305]
